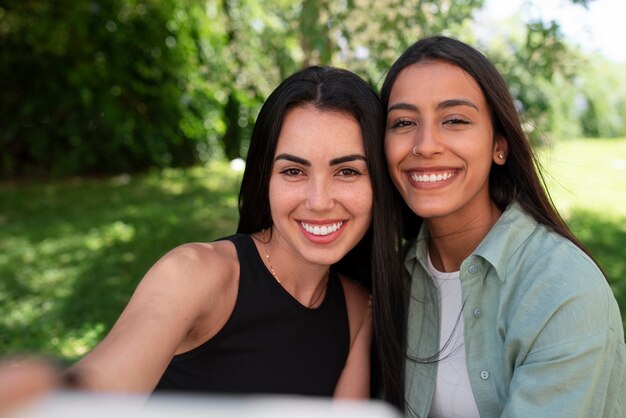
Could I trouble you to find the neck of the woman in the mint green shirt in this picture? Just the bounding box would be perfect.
[425,202,502,272]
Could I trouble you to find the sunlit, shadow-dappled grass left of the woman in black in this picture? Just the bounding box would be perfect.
[0,163,240,360]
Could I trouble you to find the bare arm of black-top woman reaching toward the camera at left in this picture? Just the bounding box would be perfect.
[70,243,237,392]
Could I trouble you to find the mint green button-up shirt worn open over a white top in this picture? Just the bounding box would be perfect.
[405,203,626,418]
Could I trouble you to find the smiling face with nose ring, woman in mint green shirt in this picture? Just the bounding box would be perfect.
[385,61,506,227]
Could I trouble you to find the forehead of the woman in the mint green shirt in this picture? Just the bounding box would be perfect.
[389,60,486,107]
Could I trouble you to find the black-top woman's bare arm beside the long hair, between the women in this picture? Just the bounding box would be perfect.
[333,278,372,399]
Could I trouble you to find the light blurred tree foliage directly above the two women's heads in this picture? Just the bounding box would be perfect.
[212,0,483,158]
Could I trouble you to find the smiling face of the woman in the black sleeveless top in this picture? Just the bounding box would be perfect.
[269,106,372,266]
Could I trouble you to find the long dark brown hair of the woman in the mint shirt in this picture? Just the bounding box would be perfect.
[374,36,591,410]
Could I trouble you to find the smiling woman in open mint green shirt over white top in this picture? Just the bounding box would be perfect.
[374,37,626,418]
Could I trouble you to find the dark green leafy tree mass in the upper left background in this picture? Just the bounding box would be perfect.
[0,0,220,176]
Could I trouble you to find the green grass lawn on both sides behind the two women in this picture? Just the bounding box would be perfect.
[0,139,626,362]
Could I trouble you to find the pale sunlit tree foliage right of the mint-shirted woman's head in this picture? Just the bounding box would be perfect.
[476,0,626,144]
